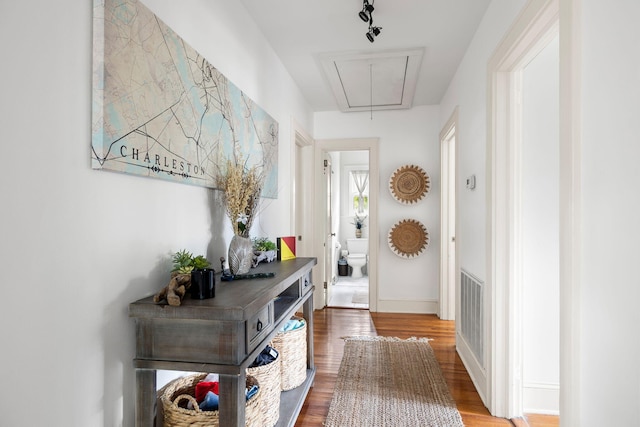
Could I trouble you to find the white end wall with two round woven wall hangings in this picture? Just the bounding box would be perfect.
[314,106,440,313]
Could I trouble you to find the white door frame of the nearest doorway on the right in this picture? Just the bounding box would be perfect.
[485,0,581,425]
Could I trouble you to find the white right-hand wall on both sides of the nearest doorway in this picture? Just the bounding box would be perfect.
[440,0,640,427]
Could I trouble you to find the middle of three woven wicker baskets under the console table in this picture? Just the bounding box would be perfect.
[247,355,281,427]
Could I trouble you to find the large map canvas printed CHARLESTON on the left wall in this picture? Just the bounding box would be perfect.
[91,0,278,198]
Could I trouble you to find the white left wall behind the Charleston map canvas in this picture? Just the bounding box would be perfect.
[0,0,313,427]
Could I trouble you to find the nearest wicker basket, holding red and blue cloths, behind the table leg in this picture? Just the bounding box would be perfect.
[158,373,265,427]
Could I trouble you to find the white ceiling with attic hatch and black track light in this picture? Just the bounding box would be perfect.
[240,0,491,111]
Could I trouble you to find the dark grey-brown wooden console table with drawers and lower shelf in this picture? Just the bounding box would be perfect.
[129,258,316,427]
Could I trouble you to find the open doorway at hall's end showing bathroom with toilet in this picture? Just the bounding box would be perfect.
[314,138,379,311]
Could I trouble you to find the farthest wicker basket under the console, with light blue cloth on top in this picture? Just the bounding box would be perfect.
[271,316,307,391]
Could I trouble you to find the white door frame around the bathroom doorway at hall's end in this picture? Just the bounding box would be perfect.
[313,138,380,312]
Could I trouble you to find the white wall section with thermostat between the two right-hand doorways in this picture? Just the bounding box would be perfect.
[440,0,525,281]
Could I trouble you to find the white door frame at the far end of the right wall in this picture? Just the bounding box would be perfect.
[438,107,459,320]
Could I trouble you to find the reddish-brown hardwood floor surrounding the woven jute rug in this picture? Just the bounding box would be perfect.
[295,308,559,427]
